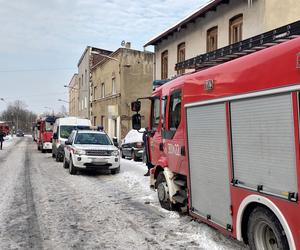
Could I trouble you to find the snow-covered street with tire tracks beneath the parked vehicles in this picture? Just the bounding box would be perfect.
[0,137,248,250]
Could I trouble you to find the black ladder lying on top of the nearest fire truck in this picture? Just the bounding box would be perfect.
[175,21,300,71]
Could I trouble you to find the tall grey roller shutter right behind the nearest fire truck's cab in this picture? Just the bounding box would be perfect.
[187,103,232,228]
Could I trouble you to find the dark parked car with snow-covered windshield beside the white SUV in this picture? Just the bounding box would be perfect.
[121,128,145,161]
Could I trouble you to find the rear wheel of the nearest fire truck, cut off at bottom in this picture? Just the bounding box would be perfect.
[247,207,289,250]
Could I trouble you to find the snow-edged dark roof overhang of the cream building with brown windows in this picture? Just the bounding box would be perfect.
[144,0,229,47]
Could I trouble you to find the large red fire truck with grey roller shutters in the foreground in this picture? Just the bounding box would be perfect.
[132,22,300,249]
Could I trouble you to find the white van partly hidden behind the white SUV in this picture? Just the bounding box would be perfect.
[52,117,91,161]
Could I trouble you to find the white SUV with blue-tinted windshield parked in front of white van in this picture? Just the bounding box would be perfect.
[63,130,120,175]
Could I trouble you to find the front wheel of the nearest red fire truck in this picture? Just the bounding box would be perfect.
[156,172,173,210]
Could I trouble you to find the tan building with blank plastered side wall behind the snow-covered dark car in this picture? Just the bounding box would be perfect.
[91,46,154,139]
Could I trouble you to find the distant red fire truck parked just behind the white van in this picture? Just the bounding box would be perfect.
[36,116,56,153]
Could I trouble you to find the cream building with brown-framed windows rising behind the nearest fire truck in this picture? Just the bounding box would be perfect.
[145,0,300,80]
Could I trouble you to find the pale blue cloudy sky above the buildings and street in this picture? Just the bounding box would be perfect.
[0,0,208,113]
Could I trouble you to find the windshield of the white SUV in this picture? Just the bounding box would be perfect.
[74,133,112,145]
